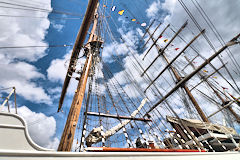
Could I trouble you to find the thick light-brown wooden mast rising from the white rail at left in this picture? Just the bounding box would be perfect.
[58,5,98,151]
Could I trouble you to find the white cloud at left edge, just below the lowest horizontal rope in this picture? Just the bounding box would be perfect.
[0,59,51,104]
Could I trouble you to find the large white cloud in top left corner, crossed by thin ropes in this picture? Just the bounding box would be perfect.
[0,0,51,61]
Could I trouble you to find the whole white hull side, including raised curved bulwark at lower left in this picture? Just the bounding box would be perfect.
[0,112,240,160]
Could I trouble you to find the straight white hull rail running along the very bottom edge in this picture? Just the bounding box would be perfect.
[0,150,240,160]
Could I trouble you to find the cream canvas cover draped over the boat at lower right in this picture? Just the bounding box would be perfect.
[166,116,237,135]
